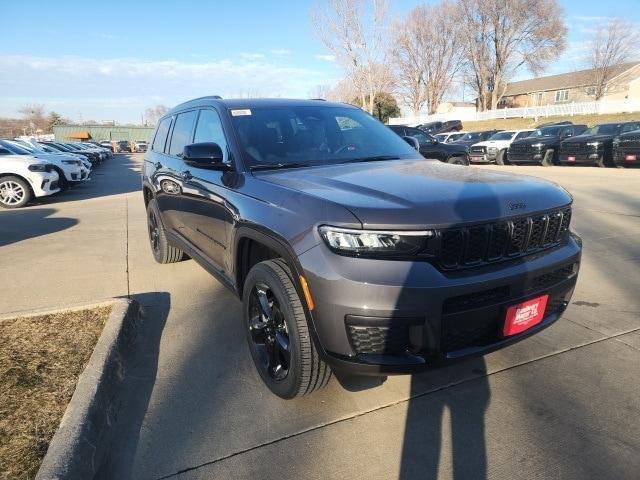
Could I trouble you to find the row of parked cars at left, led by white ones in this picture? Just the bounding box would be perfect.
[0,139,113,208]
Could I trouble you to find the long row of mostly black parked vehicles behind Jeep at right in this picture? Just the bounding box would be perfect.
[389,121,640,167]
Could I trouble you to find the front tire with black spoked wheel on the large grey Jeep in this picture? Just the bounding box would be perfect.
[242,259,331,399]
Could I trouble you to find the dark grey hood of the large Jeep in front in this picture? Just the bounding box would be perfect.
[254,160,571,229]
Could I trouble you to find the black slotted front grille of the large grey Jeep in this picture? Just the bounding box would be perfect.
[436,207,571,270]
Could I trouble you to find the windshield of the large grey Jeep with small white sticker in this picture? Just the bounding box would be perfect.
[231,105,416,168]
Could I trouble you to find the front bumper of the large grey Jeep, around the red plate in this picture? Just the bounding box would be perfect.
[299,236,581,375]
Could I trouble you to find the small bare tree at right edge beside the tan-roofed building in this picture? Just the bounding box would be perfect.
[588,18,640,100]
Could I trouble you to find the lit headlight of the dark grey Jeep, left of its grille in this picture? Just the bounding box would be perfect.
[318,225,435,256]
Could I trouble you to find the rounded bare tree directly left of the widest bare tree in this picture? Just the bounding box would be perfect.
[392,0,462,115]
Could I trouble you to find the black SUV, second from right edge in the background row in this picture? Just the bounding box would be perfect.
[558,121,640,167]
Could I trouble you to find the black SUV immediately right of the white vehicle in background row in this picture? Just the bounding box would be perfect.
[507,123,587,167]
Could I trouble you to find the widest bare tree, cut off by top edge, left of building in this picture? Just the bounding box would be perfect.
[457,0,567,110]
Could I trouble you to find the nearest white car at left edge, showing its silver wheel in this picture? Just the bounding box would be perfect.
[0,147,60,208]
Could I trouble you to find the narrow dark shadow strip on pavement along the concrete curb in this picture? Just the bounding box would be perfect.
[95,292,171,479]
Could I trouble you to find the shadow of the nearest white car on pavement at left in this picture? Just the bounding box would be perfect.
[0,208,78,247]
